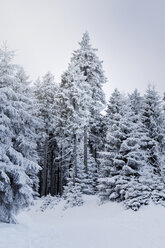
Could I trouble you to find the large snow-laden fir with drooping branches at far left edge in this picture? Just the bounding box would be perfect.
[0,46,39,222]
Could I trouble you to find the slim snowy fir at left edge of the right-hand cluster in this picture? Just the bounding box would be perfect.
[99,89,124,201]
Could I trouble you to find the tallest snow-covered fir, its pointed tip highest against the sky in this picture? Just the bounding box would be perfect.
[71,32,106,186]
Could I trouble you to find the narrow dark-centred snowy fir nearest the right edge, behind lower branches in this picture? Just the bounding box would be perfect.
[141,86,164,174]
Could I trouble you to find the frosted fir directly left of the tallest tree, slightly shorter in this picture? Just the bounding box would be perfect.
[57,62,96,196]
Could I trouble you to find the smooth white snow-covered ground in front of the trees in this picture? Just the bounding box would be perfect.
[0,196,165,248]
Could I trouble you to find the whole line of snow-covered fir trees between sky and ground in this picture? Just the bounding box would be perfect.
[0,33,165,222]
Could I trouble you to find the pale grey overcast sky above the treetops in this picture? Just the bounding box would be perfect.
[0,0,165,97]
